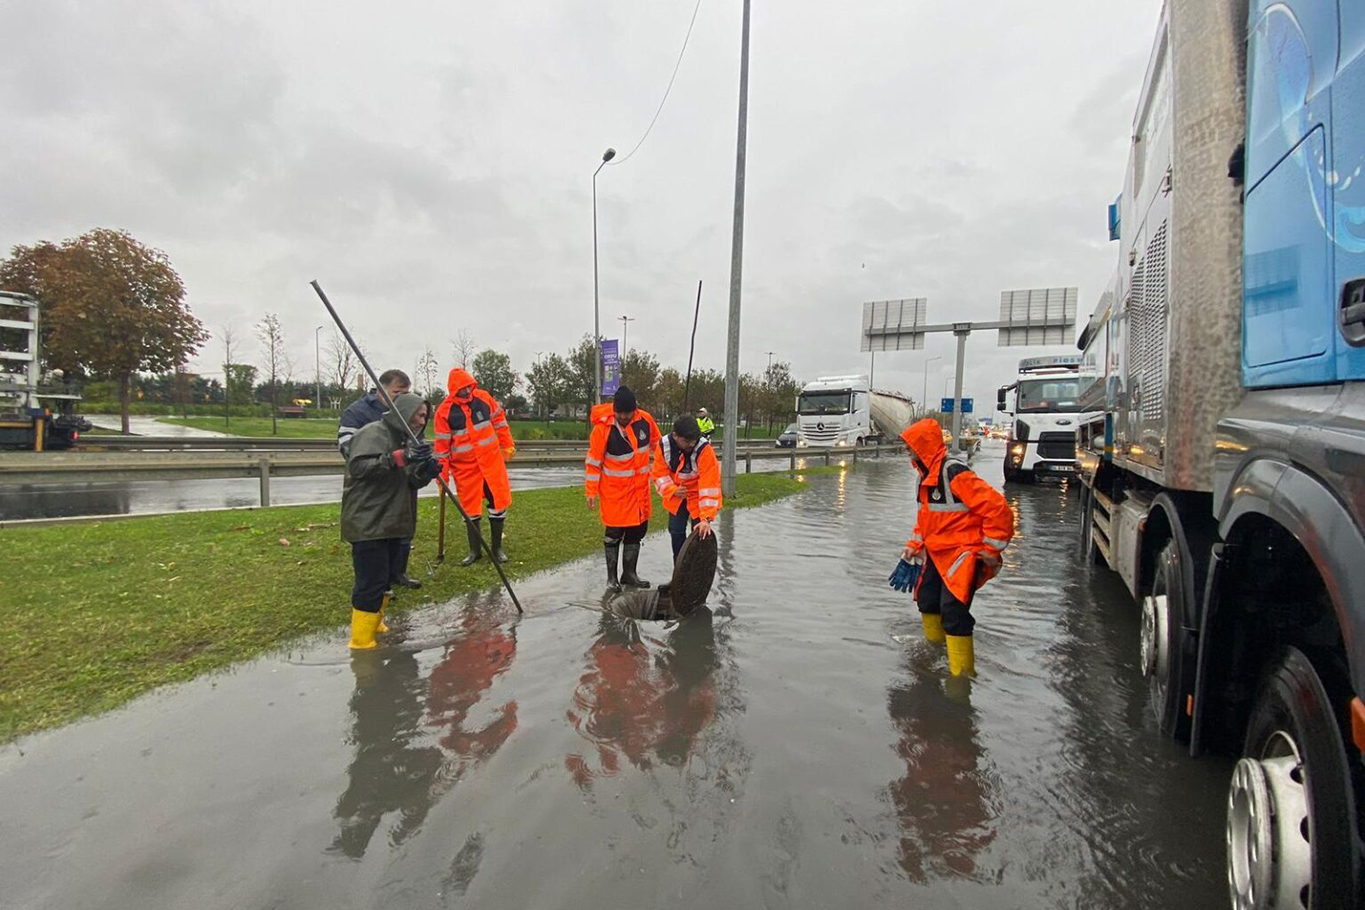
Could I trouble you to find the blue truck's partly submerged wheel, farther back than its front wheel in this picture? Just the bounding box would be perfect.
[1140,540,1194,741]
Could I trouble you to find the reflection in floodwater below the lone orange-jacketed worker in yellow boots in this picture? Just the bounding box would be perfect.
[886,643,995,883]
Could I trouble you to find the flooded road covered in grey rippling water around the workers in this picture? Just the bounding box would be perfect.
[0,450,1230,910]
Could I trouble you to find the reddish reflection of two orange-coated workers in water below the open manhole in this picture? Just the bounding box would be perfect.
[564,607,718,790]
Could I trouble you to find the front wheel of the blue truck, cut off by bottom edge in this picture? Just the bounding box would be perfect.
[1227,648,1358,910]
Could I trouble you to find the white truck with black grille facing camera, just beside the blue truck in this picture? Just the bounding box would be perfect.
[995,355,1097,483]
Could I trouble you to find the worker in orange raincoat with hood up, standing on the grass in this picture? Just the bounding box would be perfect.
[435,367,516,566]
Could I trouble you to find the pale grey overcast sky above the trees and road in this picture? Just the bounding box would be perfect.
[0,0,1160,411]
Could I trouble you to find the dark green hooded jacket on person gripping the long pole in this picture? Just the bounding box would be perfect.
[341,393,430,543]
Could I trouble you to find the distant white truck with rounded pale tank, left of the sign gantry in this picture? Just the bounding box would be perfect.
[796,377,915,449]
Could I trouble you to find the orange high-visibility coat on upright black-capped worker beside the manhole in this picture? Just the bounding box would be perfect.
[583,402,659,528]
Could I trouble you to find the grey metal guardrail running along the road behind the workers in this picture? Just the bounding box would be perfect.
[0,443,882,506]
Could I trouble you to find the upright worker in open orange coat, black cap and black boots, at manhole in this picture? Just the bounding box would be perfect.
[583,386,659,591]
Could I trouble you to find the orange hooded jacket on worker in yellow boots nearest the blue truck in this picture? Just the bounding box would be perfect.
[901,417,1014,603]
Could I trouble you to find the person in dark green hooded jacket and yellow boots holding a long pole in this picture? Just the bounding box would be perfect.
[341,393,441,651]
